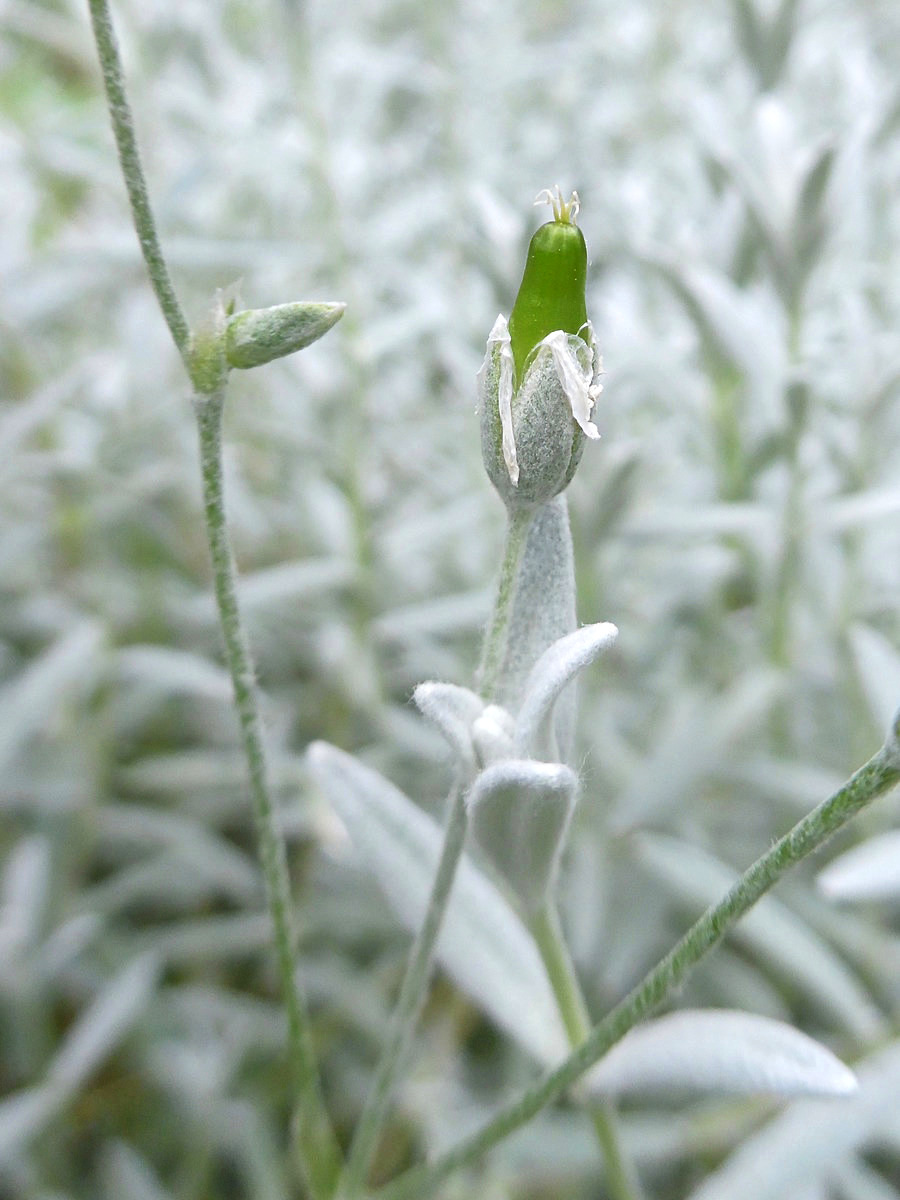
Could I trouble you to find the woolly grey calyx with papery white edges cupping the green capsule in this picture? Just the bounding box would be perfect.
[478,316,602,508]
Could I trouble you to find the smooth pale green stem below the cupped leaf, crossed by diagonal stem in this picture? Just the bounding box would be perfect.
[532,901,643,1200]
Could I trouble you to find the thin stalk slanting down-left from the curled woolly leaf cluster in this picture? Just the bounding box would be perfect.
[340,781,468,1196]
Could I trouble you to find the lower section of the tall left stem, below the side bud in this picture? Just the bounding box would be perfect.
[194,390,341,1200]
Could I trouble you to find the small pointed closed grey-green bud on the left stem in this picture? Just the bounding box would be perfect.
[224,300,347,368]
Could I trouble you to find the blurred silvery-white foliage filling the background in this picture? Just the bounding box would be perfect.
[0,0,900,1200]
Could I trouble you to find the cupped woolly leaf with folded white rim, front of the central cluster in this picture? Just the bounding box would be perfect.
[467,758,577,912]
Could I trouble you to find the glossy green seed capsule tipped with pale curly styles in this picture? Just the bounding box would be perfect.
[509,188,590,385]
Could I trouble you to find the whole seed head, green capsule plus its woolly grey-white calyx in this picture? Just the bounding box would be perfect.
[478,188,602,508]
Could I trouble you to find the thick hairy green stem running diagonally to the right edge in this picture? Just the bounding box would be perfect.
[377,728,900,1200]
